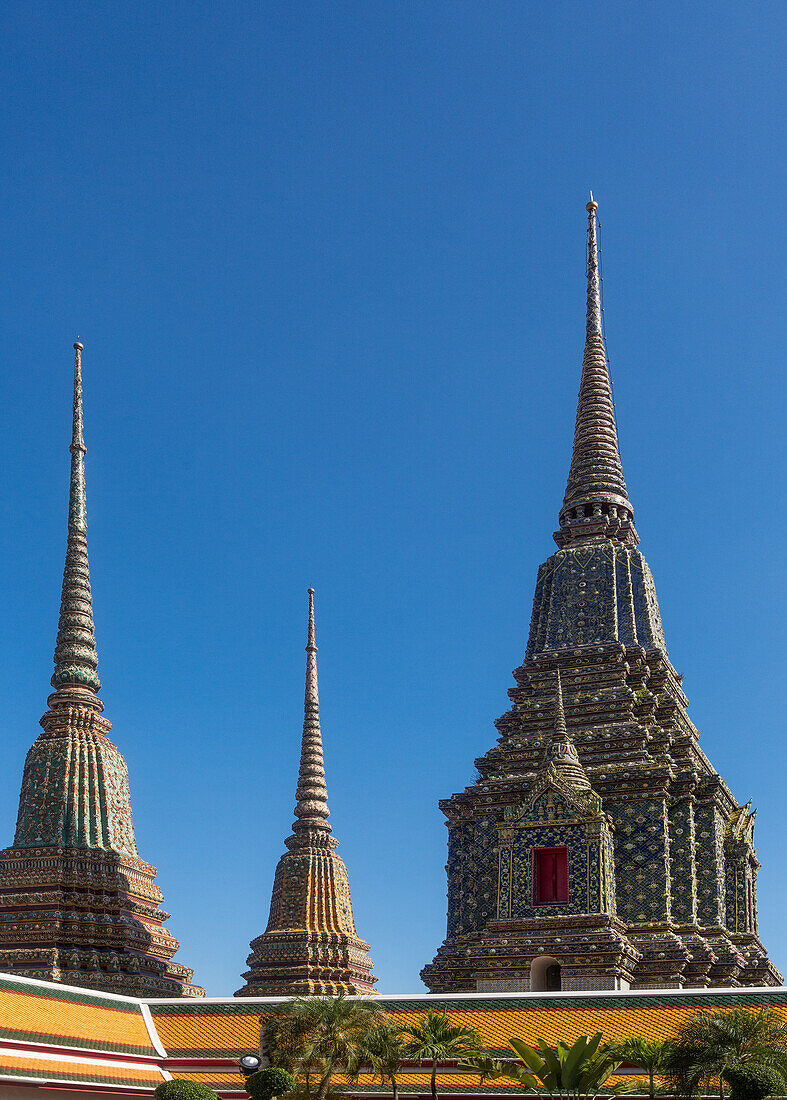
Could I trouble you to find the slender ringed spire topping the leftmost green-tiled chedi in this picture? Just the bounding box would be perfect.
[52,340,101,702]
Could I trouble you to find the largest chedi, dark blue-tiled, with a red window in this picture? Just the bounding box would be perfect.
[422,200,780,992]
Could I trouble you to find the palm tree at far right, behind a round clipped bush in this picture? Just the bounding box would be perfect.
[665,1008,787,1100]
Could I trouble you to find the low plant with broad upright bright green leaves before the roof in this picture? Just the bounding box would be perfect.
[460,1032,627,1100]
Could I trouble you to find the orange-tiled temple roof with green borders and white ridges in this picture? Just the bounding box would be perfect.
[0,976,787,1098]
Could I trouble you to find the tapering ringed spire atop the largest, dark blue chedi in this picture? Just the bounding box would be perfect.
[555,199,640,547]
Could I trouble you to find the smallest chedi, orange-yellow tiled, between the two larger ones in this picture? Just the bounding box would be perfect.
[236,589,376,997]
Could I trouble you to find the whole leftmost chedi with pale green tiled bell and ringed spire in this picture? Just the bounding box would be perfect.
[0,343,204,997]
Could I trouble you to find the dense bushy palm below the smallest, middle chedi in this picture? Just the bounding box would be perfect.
[261,993,380,1100]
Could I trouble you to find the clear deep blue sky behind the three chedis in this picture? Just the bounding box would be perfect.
[0,0,787,996]
